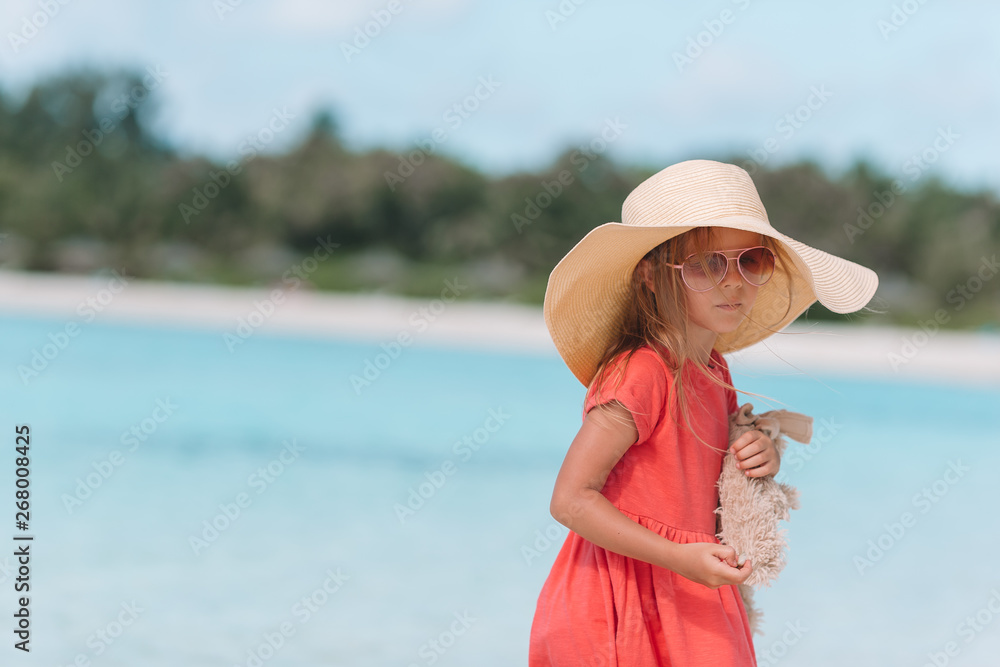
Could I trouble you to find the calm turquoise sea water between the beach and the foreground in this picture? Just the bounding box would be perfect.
[0,317,1000,667]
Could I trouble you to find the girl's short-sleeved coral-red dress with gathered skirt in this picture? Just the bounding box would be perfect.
[529,346,757,667]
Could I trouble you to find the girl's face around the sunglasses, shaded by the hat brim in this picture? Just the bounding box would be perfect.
[684,227,763,335]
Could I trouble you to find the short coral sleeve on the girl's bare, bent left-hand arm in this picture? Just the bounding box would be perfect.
[583,348,670,444]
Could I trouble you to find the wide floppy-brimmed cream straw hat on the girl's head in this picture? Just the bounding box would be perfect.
[543,160,878,386]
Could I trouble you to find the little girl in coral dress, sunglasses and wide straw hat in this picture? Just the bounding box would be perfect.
[529,160,878,667]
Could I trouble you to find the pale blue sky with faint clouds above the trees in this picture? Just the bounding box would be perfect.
[0,0,1000,192]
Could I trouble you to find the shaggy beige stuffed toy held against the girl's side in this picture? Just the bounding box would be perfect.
[715,403,812,634]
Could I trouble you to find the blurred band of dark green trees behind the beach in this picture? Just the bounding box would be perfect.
[0,71,1000,327]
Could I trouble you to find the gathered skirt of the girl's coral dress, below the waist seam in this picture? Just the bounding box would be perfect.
[529,511,756,667]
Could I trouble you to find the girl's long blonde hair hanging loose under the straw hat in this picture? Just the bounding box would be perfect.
[585,227,794,449]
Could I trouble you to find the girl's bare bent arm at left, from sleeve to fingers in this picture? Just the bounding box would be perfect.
[549,401,751,588]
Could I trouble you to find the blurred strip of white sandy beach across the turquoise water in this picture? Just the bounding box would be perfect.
[0,271,1000,387]
